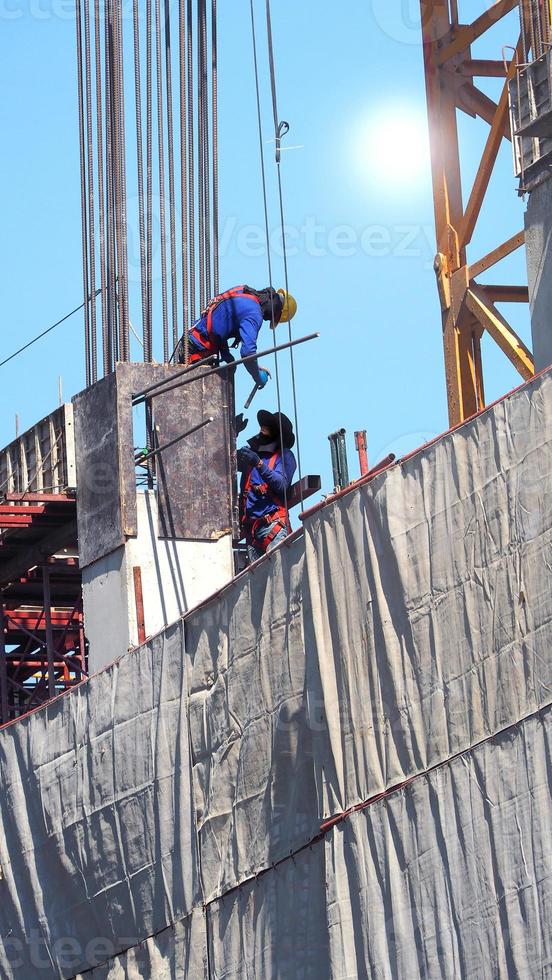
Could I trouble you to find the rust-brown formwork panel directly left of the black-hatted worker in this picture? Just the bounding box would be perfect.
[154,367,235,541]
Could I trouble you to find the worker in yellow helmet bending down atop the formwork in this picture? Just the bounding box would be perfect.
[178,286,297,388]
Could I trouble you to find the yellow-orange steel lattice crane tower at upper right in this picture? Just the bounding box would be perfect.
[420,0,552,425]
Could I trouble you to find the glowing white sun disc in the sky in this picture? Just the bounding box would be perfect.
[355,106,430,192]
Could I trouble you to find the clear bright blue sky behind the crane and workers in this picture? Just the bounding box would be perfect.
[0,0,530,491]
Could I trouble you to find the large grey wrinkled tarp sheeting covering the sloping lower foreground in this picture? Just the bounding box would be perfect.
[0,374,552,980]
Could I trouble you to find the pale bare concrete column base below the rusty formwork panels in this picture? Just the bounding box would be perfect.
[83,492,233,672]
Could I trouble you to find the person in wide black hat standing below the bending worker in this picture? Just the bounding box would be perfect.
[238,410,297,562]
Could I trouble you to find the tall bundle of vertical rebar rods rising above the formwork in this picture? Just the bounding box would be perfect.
[76,0,219,384]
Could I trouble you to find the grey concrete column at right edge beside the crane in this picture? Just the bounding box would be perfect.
[525,178,552,371]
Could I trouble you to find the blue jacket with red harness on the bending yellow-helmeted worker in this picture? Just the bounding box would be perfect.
[190,286,263,384]
